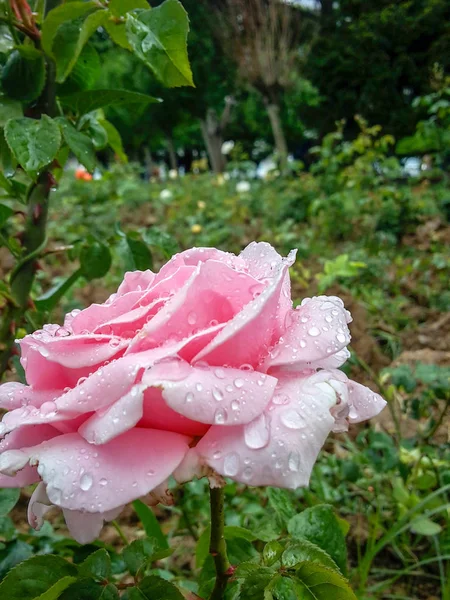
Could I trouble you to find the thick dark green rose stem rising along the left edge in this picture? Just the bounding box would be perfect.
[0,0,59,378]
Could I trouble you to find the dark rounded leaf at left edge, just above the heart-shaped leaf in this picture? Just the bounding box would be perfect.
[1,49,45,103]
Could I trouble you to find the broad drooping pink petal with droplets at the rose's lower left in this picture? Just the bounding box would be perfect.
[23,428,190,513]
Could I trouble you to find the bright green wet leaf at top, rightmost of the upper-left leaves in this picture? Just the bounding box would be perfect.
[127,0,194,87]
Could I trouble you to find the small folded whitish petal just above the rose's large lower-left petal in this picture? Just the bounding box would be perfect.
[78,385,144,444]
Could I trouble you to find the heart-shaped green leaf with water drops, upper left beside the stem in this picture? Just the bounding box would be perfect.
[5,115,61,179]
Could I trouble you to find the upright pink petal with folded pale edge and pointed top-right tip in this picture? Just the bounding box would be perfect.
[194,251,295,367]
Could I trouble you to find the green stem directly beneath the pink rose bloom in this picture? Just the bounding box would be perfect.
[209,487,230,600]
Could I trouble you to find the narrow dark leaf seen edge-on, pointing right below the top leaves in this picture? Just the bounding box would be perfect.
[60,90,161,115]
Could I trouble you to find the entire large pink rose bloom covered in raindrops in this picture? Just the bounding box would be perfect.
[0,243,385,542]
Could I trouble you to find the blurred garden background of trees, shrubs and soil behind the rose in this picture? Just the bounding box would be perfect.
[0,0,450,600]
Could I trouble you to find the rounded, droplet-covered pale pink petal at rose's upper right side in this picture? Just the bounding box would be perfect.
[264,296,351,371]
